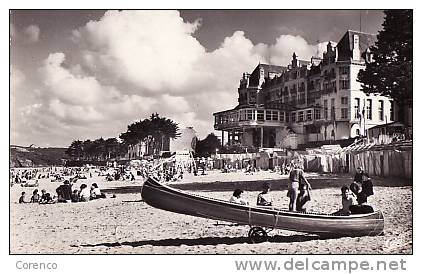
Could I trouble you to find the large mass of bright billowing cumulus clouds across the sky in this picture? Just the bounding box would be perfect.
[11,11,323,148]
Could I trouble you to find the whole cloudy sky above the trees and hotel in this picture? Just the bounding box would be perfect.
[10,10,384,147]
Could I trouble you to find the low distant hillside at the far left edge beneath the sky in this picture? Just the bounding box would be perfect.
[10,145,68,167]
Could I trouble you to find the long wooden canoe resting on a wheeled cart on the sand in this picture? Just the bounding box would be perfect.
[142,178,384,236]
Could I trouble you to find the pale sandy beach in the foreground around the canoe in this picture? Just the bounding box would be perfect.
[10,171,413,254]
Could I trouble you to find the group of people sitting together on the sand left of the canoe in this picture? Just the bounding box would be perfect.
[19,180,106,204]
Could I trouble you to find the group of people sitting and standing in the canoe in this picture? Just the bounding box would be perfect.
[229,163,374,215]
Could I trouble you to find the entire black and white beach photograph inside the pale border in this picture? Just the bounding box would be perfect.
[8,5,416,260]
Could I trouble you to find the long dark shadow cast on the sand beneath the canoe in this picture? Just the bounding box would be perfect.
[72,235,336,247]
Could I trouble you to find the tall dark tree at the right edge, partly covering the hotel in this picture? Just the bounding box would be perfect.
[358,10,413,122]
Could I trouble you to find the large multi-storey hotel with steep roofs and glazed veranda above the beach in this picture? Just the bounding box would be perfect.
[214,30,395,149]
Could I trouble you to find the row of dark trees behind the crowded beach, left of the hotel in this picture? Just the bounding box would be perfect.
[66,113,180,160]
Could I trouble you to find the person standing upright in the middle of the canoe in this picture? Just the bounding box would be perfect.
[287,163,311,211]
